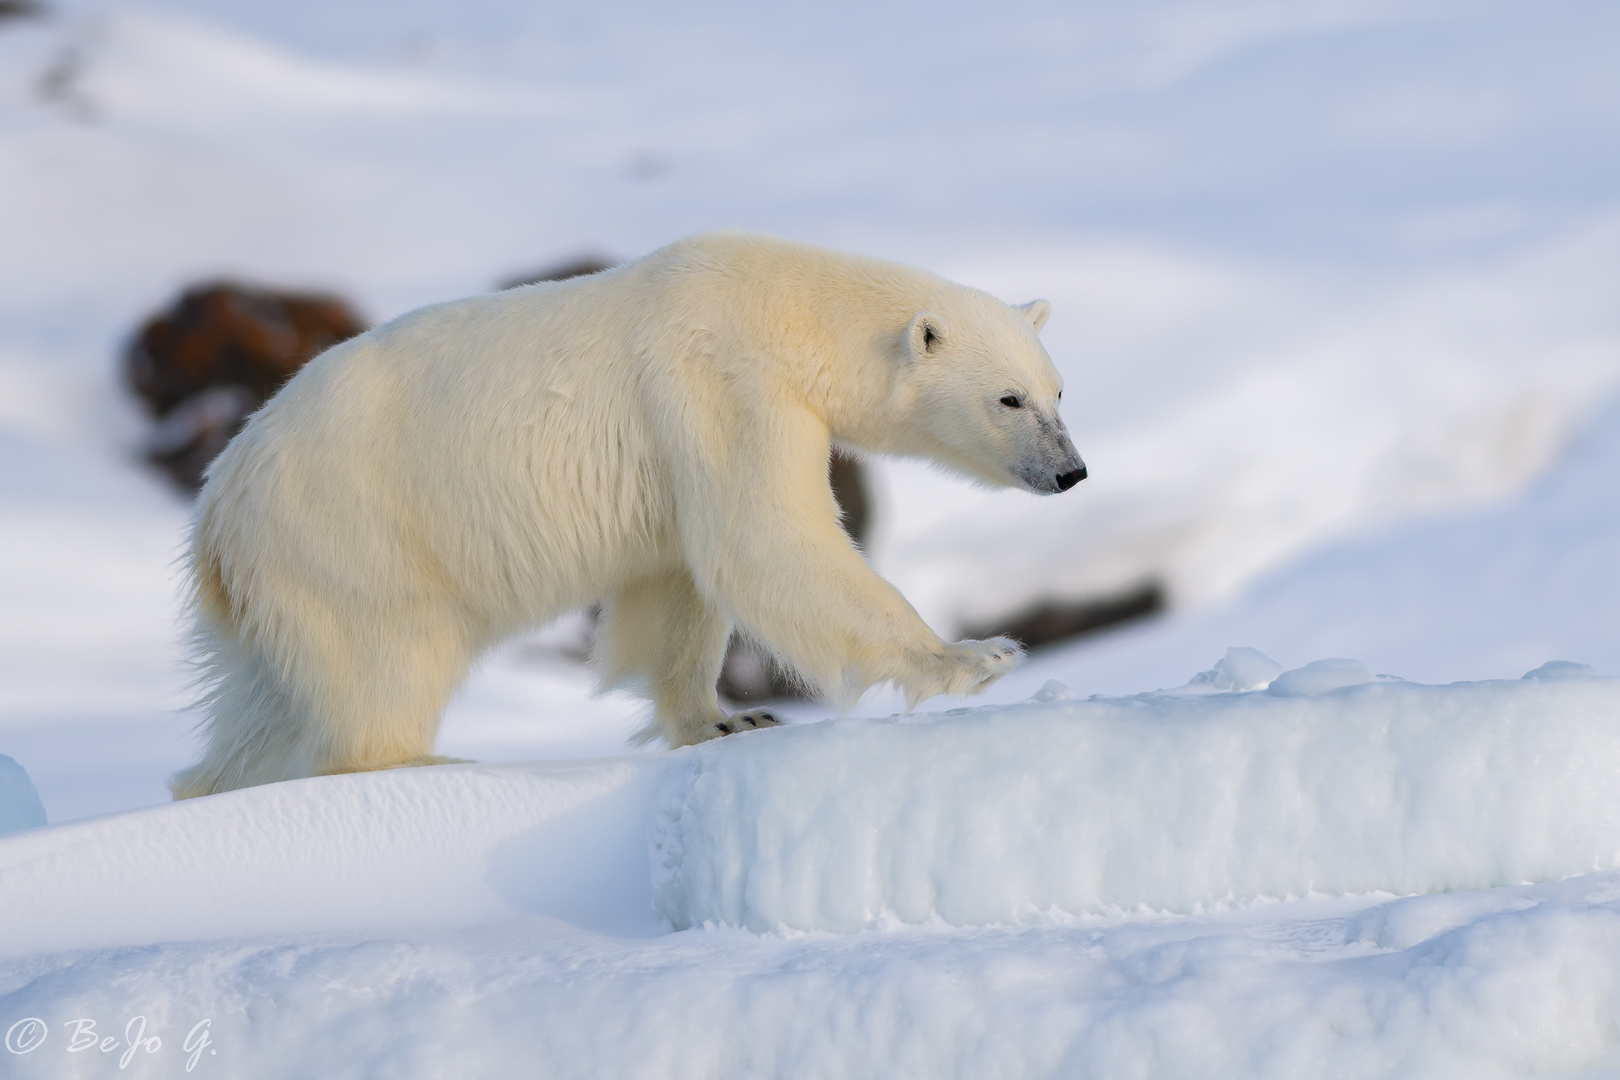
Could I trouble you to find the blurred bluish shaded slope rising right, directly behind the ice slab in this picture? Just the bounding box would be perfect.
[965,400,1620,704]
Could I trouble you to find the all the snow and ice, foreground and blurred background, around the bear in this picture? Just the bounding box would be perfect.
[9,0,1620,1080]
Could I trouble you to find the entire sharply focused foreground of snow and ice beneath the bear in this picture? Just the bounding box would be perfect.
[0,669,1620,1077]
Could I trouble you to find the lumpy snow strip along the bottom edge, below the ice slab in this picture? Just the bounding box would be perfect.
[15,873,1620,1080]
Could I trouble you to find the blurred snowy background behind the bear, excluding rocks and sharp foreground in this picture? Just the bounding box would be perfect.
[0,0,1620,821]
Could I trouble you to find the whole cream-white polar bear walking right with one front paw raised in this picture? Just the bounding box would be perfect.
[170,233,1085,798]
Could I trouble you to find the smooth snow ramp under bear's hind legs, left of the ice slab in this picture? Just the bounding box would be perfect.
[0,758,663,955]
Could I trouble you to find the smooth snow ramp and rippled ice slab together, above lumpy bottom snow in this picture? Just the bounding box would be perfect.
[0,656,1620,954]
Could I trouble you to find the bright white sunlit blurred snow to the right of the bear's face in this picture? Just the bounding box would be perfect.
[875,223,1620,627]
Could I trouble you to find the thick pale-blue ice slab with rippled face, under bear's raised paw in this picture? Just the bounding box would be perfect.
[653,661,1620,931]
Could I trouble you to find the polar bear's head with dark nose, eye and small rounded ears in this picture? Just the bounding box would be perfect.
[901,290,1085,495]
